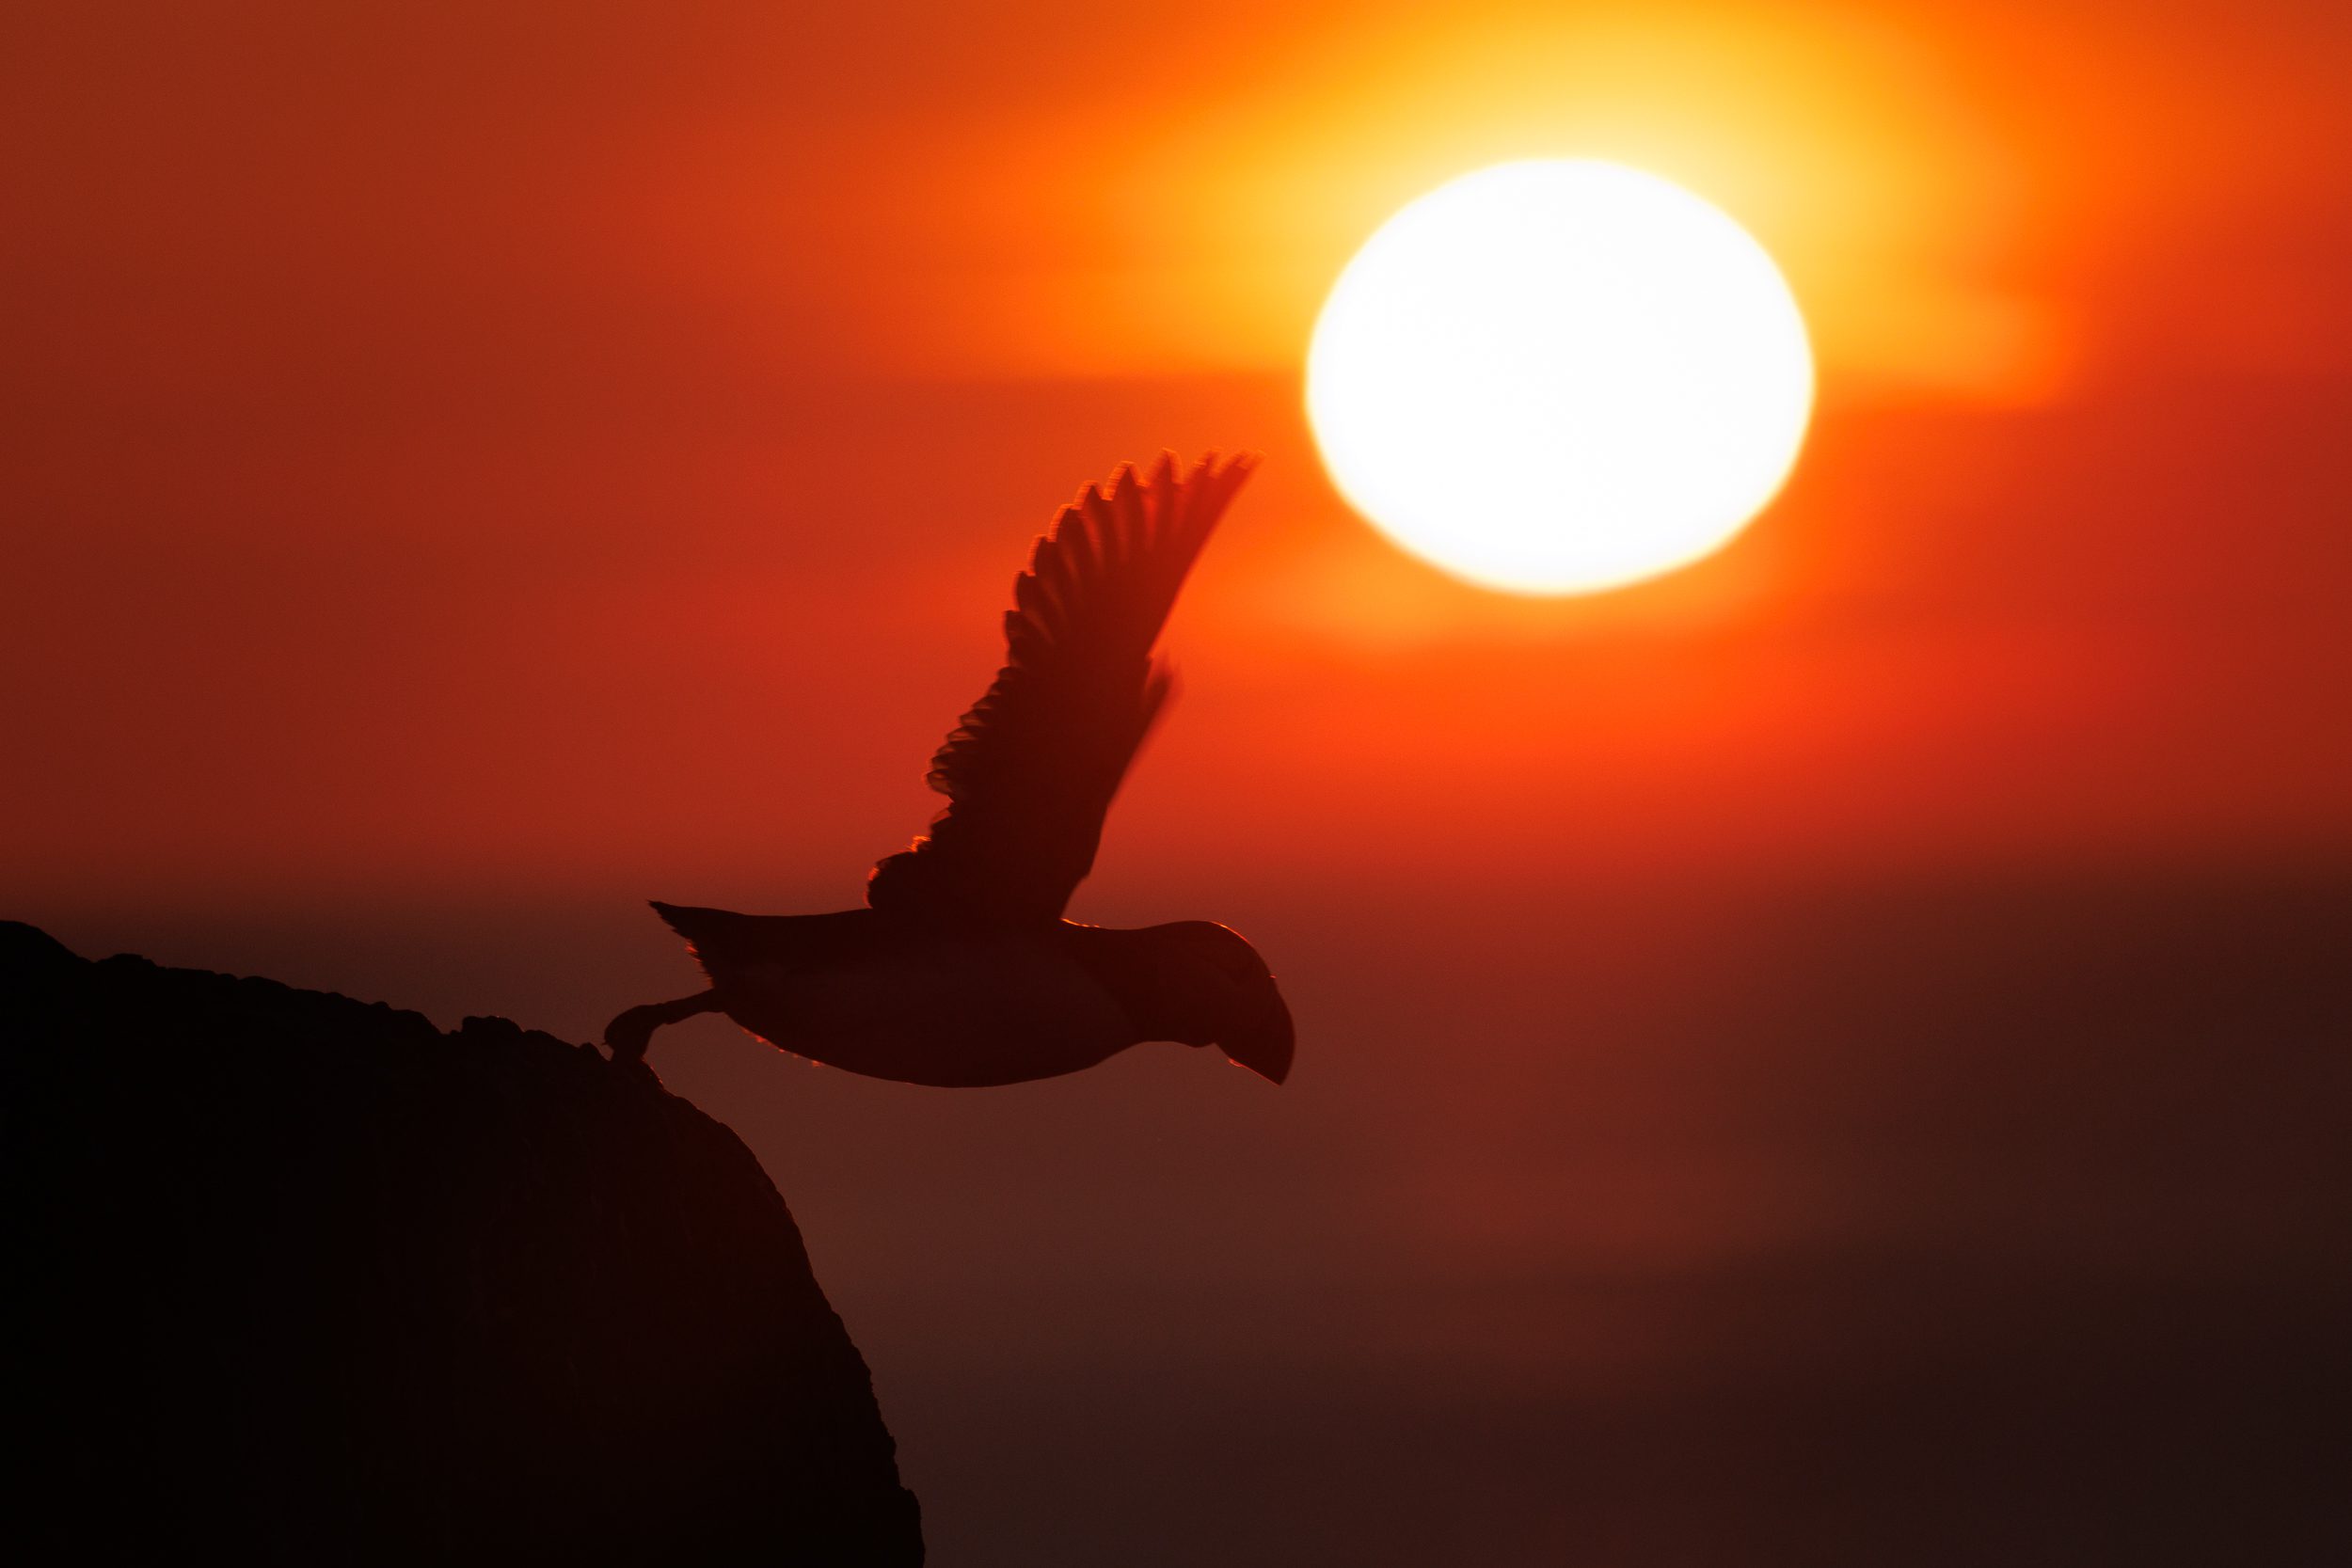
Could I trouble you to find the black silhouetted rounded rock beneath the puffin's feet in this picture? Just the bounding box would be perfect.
[0,924,922,1566]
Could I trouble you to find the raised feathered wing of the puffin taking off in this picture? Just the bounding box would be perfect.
[866,453,1256,922]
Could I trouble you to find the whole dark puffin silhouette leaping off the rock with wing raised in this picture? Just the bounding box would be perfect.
[605,453,1294,1088]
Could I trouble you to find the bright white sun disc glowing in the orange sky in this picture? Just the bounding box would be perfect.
[1308,160,1814,594]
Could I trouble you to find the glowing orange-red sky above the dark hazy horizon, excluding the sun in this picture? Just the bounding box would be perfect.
[0,5,2352,921]
